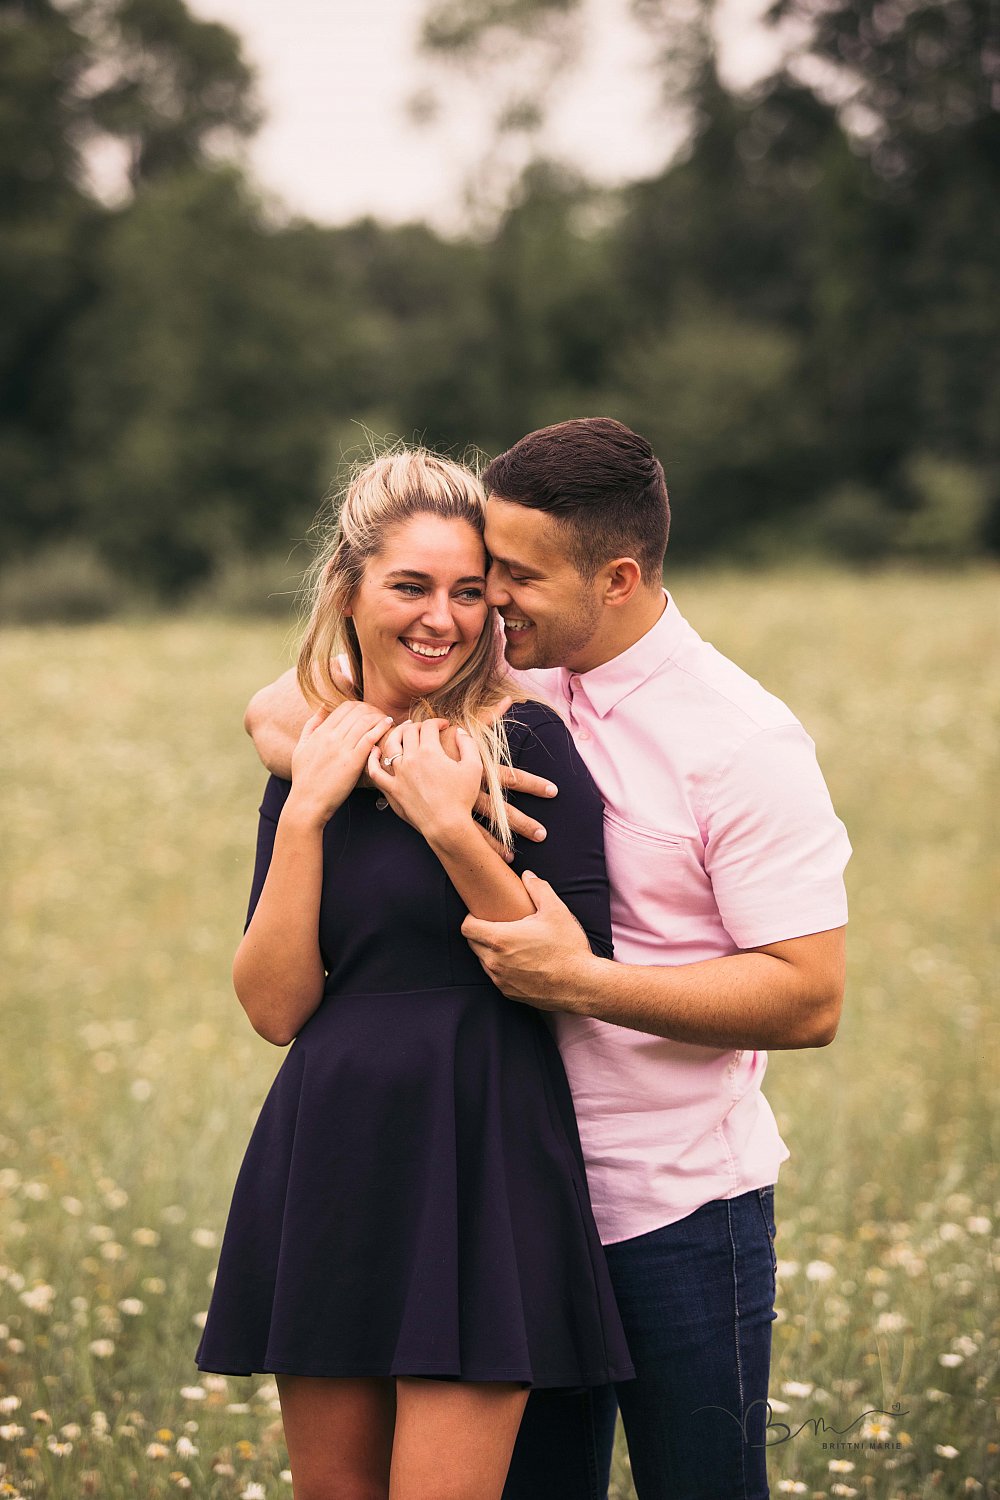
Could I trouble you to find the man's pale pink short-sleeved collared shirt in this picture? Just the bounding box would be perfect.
[519,597,850,1244]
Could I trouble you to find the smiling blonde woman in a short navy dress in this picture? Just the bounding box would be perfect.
[195,452,633,1500]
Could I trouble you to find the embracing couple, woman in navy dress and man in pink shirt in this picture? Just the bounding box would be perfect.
[195,417,850,1500]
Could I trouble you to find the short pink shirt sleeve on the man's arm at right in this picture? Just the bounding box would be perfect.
[705,722,852,948]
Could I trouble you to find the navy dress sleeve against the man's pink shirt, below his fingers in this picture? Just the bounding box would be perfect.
[507,704,613,959]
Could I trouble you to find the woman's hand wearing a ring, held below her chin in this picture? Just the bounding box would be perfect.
[367,719,483,843]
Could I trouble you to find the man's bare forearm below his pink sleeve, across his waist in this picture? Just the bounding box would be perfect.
[552,951,843,1050]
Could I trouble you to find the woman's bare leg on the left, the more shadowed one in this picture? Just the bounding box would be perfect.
[274,1376,396,1500]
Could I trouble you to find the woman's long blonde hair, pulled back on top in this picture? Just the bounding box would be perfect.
[295,449,528,849]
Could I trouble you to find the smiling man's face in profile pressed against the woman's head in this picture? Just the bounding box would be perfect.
[486,498,603,672]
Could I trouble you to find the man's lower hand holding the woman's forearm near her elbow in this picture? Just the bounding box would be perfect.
[462,870,594,1011]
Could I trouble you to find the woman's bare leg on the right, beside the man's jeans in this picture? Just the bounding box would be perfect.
[389,1376,528,1500]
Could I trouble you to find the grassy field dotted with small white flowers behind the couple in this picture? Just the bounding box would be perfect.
[0,572,1000,1500]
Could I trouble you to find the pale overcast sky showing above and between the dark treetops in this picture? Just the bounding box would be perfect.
[189,0,777,228]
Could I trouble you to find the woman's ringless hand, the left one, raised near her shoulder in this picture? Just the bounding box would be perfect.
[285,701,393,824]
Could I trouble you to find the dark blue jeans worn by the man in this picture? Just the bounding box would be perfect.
[504,1187,775,1500]
